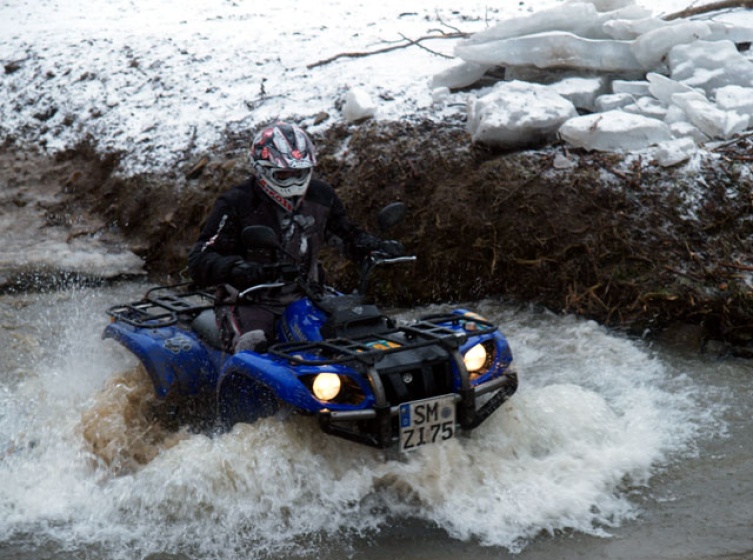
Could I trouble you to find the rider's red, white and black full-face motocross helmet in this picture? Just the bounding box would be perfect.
[251,122,316,205]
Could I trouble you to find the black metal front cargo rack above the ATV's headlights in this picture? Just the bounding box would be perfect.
[269,313,497,366]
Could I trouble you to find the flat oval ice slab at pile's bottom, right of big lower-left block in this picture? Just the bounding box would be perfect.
[560,110,672,152]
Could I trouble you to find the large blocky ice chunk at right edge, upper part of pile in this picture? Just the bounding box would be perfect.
[669,41,753,93]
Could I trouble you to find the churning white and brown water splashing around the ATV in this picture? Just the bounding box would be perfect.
[0,284,718,559]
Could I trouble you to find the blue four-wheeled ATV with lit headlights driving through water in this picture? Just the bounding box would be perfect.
[103,203,518,451]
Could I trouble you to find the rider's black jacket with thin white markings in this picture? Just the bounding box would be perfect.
[188,177,379,287]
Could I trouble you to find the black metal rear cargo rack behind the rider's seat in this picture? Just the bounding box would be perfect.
[107,284,214,329]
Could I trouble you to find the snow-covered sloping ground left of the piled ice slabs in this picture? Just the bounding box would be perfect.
[0,0,524,175]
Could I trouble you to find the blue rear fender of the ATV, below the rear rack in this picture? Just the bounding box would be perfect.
[102,322,222,399]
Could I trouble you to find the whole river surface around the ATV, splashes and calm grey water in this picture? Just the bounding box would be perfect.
[0,283,753,560]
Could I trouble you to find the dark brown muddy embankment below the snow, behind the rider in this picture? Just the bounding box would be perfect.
[3,123,753,356]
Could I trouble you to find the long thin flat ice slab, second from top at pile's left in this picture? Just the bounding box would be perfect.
[455,31,643,71]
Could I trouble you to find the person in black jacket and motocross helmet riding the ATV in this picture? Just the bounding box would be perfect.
[188,122,404,352]
